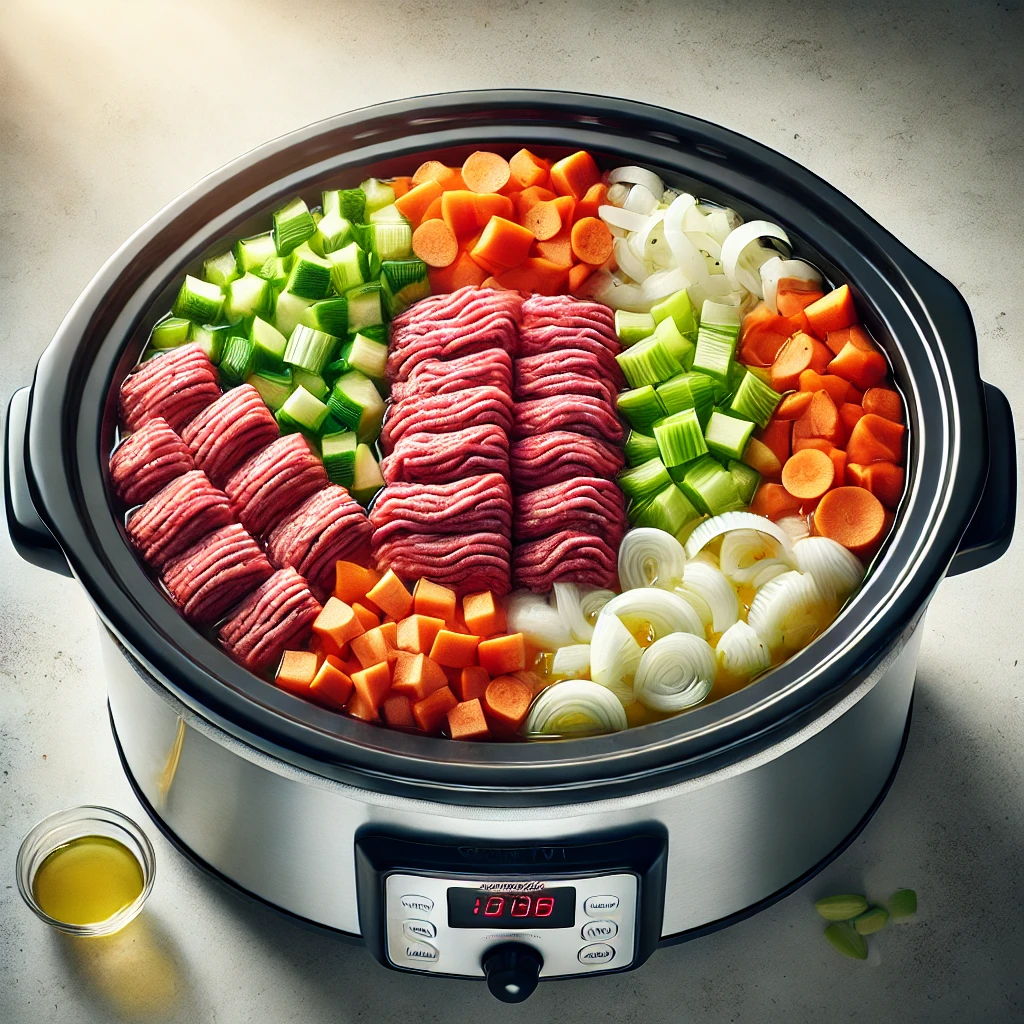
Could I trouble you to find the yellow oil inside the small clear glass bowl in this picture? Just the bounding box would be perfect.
[32,836,145,926]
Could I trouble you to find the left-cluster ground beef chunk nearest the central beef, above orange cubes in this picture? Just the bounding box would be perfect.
[266,483,371,599]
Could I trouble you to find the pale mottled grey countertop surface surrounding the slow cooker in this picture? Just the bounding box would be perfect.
[0,0,1024,1024]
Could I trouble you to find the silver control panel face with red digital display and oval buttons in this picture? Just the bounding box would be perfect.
[384,871,638,978]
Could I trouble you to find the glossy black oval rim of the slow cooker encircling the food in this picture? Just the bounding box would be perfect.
[22,90,987,803]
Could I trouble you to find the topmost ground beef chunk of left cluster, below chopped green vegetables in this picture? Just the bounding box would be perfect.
[120,344,220,431]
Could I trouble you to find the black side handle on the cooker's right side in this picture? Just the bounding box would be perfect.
[948,382,1017,575]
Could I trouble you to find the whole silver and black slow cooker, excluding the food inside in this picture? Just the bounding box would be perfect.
[5,91,1016,1000]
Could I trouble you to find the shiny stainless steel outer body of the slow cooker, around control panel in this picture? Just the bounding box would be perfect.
[100,618,922,942]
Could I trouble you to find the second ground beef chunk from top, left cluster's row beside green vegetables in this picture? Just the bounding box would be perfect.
[181,384,280,485]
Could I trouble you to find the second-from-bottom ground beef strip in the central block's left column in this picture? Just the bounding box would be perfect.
[370,473,512,550]
